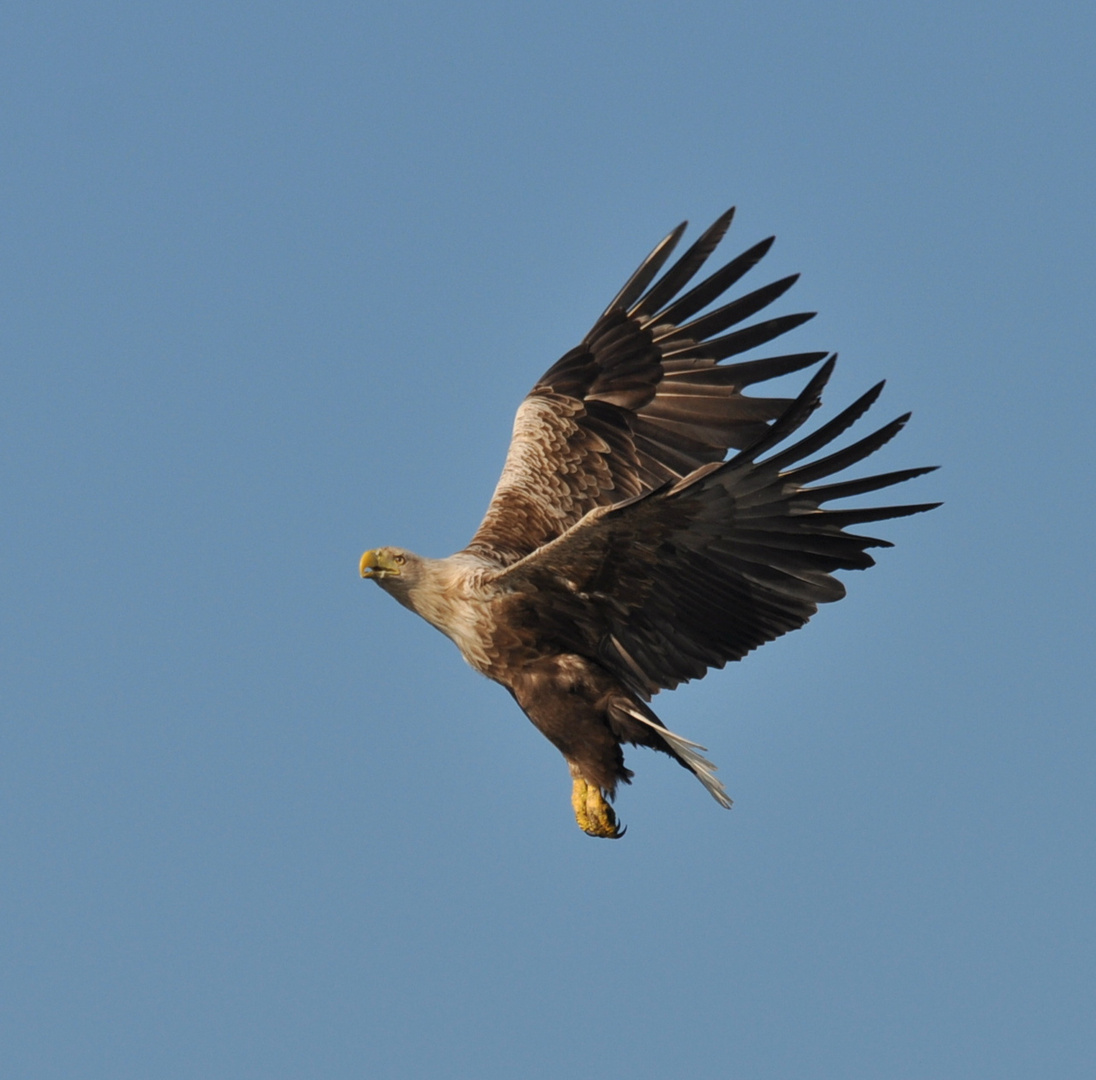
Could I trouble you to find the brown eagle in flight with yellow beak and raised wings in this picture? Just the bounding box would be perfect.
[361,209,938,838]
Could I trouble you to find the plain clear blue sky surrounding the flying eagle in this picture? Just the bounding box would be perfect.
[0,0,1096,1080]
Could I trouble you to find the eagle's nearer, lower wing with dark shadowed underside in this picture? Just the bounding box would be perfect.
[499,360,938,700]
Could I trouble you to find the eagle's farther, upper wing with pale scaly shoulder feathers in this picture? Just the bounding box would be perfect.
[467,209,826,565]
